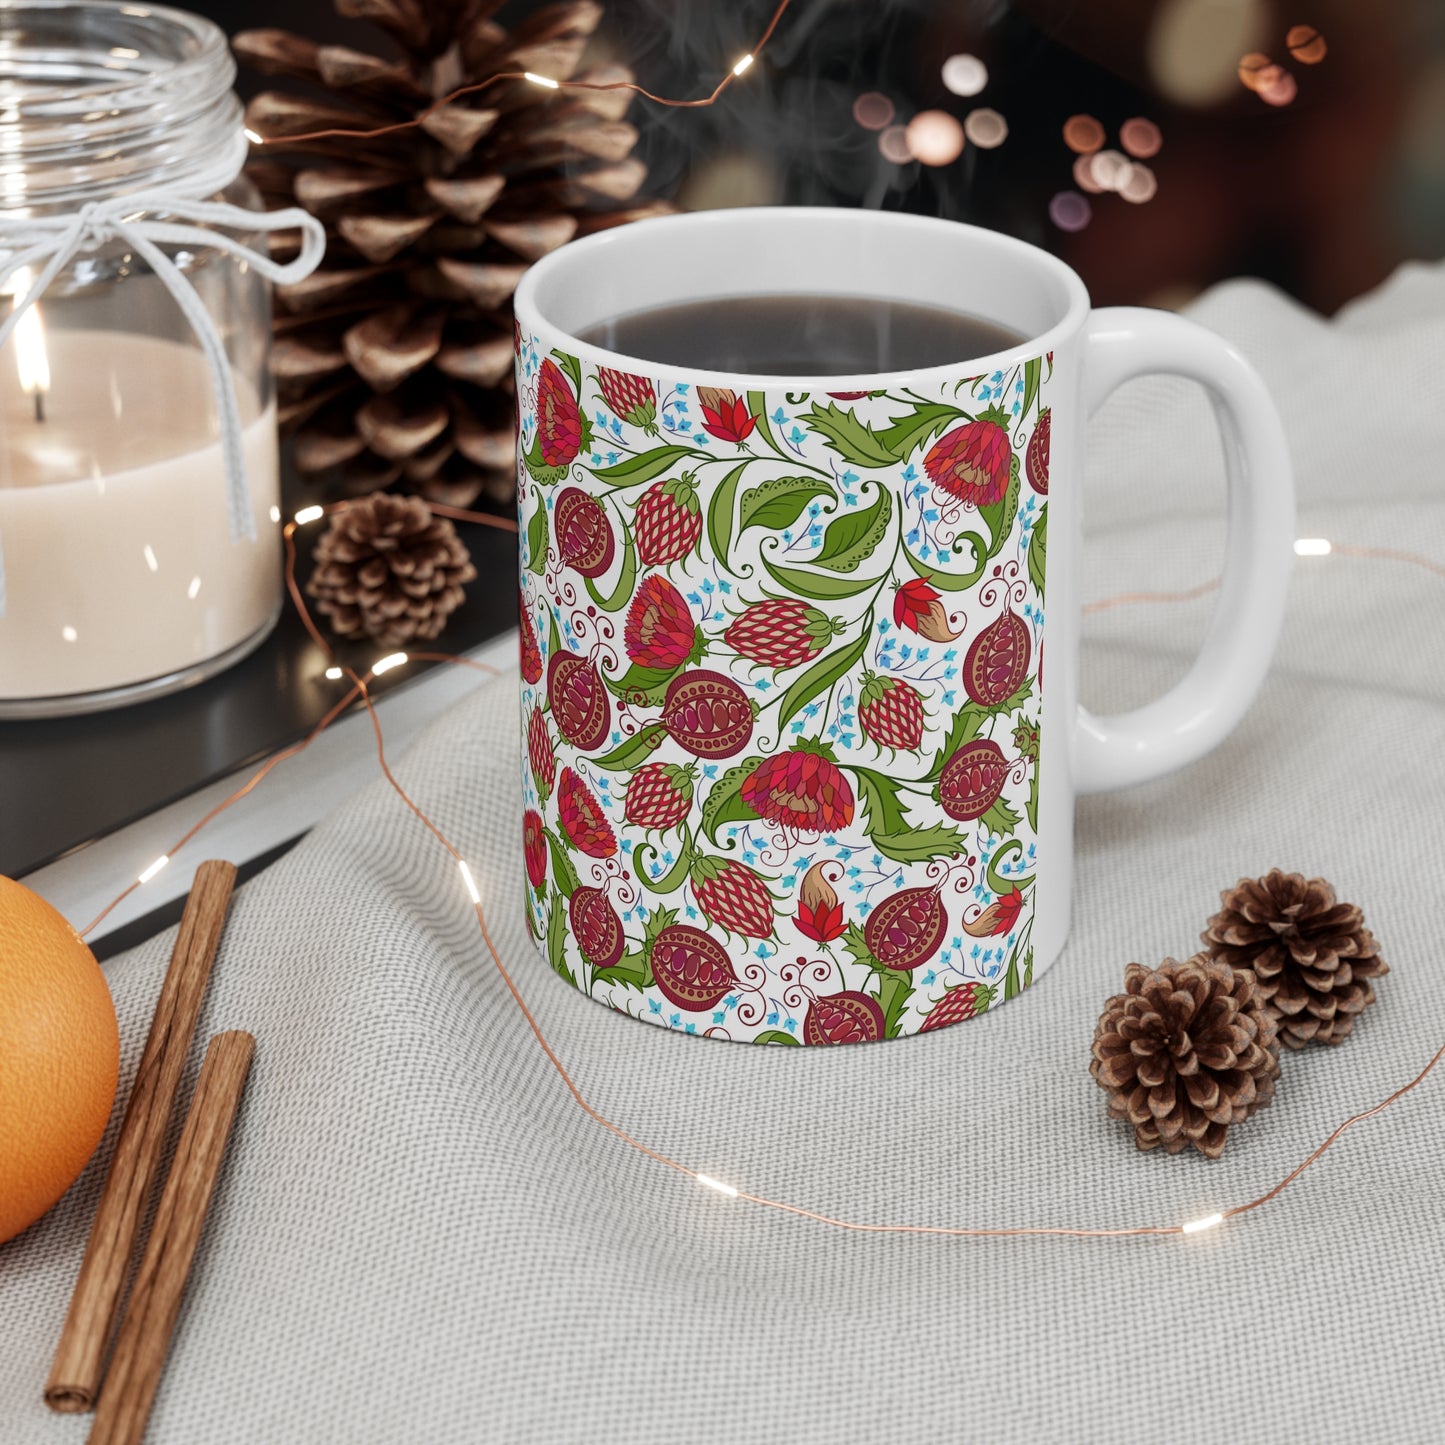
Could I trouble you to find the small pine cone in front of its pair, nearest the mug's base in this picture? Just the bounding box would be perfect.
[1090,954,1279,1159]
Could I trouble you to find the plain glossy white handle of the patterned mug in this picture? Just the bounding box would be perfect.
[1074,306,1295,793]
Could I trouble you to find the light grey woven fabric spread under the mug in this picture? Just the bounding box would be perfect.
[0,267,1445,1445]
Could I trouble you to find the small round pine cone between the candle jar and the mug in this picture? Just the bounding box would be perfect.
[306,493,477,647]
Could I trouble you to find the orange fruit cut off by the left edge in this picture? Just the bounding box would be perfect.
[0,877,120,1243]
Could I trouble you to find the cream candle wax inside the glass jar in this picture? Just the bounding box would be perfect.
[0,329,280,705]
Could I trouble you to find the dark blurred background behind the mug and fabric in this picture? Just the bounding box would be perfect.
[206,0,1445,312]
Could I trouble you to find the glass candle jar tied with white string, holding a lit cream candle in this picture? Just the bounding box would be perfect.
[0,0,296,717]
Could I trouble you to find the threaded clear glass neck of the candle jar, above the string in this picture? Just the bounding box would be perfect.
[0,0,244,214]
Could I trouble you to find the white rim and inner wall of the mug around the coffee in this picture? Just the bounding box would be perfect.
[516,207,1088,390]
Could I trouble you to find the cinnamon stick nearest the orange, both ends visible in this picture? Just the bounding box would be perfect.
[45,860,236,1415]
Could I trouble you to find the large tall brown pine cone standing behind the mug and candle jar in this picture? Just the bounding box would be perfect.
[234,0,666,506]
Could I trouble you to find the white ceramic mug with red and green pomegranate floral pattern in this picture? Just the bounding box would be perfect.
[516,208,1293,1045]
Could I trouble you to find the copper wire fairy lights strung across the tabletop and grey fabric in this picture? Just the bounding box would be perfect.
[81,485,1445,1240]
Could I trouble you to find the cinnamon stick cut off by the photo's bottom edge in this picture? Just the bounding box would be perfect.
[90,1032,256,1445]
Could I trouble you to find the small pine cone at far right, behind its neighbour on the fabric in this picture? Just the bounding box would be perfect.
[1201,868,1390,1049]
